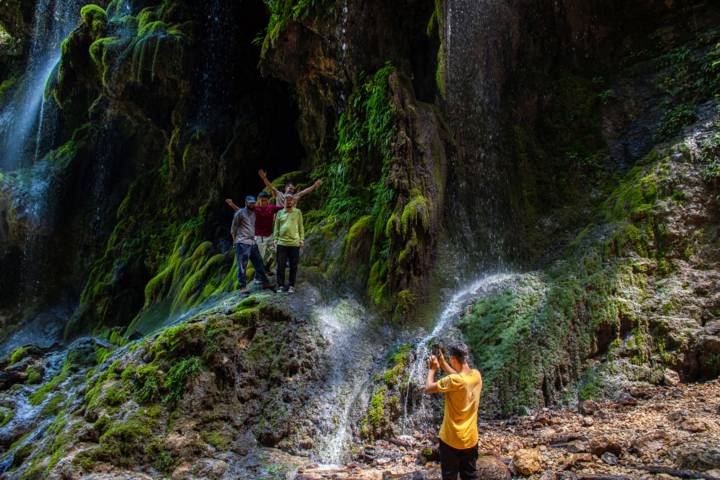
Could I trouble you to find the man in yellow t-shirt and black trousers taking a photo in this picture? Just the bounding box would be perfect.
[425,342,482,480]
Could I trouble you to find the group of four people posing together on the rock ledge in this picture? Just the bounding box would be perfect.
[225,170,322,293]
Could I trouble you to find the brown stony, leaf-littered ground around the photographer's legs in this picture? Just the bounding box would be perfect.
[295,380,720,480]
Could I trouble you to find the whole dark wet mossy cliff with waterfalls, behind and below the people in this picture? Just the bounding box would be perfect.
[0,0,720,478]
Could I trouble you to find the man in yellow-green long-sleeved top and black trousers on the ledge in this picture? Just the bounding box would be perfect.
[273,194,305,293]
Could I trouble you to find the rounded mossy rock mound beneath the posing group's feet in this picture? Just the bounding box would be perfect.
[21,296,322,474]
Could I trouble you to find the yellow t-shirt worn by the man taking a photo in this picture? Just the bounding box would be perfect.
[437,370,482,450]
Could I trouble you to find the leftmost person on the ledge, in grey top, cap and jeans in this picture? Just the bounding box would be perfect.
[230,196,272,293]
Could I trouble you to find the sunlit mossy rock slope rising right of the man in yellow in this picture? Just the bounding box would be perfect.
[459,130,719,415]
